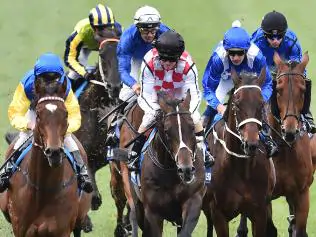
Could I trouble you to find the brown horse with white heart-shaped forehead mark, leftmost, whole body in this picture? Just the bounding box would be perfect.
[0,77,91,237]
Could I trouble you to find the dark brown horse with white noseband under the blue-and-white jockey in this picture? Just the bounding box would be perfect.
[203,69,274,237]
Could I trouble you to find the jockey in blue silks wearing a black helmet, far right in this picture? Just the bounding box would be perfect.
[252,11,316,133]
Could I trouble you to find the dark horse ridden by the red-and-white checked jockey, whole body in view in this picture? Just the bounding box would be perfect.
[131,92,206,237]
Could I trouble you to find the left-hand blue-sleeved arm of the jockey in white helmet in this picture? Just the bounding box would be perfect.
[117,36,137,88]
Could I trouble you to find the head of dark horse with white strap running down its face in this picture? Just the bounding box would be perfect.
[158,91,196,184]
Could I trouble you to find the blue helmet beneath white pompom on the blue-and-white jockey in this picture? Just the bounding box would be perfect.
[223,26,250,50]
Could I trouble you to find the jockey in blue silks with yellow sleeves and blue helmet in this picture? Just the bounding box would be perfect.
[0,53,93,192]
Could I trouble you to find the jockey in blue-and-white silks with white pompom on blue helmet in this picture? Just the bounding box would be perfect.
[202,21,277,157]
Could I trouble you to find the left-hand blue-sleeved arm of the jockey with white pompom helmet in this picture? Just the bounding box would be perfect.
[202,53,224,110]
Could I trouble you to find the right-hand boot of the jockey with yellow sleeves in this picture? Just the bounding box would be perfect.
[71,151,93,193]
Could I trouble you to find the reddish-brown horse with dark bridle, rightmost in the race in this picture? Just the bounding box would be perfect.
[239,52,316,237]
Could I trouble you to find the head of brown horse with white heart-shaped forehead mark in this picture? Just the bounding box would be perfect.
[34,75,68,167]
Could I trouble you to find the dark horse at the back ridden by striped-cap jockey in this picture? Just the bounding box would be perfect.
[75,32,121,210]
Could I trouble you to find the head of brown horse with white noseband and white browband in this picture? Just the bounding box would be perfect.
[230,68,266,156]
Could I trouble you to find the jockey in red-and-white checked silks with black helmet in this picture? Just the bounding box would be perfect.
[128,30,213,169]
